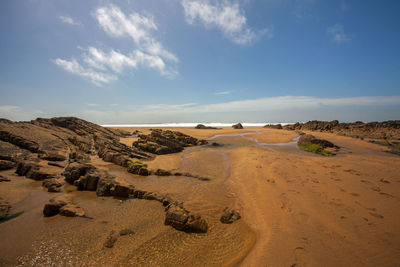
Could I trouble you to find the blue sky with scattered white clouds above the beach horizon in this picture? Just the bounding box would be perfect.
[0,0,400,124]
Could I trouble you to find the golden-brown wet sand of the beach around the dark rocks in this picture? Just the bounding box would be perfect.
[0,127,400,266]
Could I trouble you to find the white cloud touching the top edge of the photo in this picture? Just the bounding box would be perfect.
[181,0,273,45]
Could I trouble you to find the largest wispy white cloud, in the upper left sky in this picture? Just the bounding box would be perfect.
[53,5,179,86]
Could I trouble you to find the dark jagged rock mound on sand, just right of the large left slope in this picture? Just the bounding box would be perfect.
[132,129,204,155]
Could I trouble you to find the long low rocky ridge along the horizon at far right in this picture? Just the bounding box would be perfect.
[283,120,400,139]
